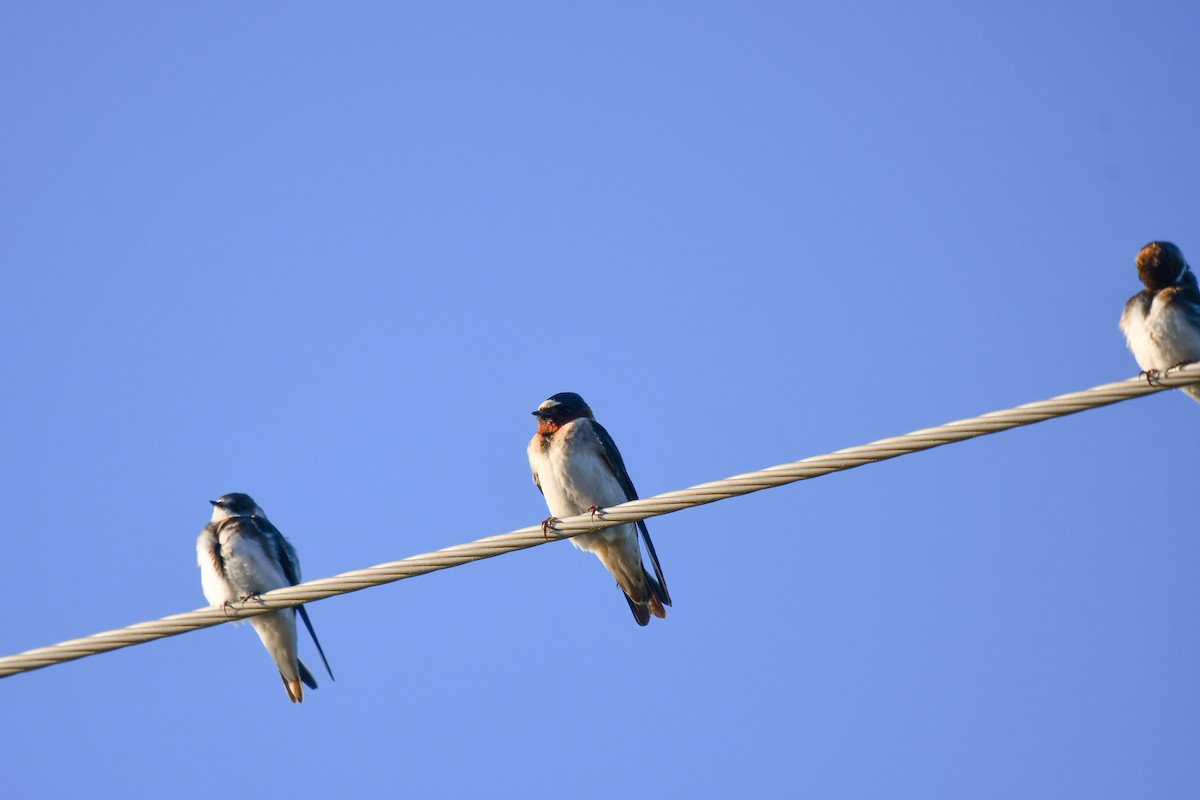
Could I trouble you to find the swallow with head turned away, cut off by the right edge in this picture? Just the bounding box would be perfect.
[1121,241,1200,401]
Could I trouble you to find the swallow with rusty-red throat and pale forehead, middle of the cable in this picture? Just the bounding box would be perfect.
[529,392,671,625]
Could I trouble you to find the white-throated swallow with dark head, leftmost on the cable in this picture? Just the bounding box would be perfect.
[196,492,334,703]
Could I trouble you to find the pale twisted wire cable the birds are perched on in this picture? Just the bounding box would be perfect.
[0,362,1200,678]
